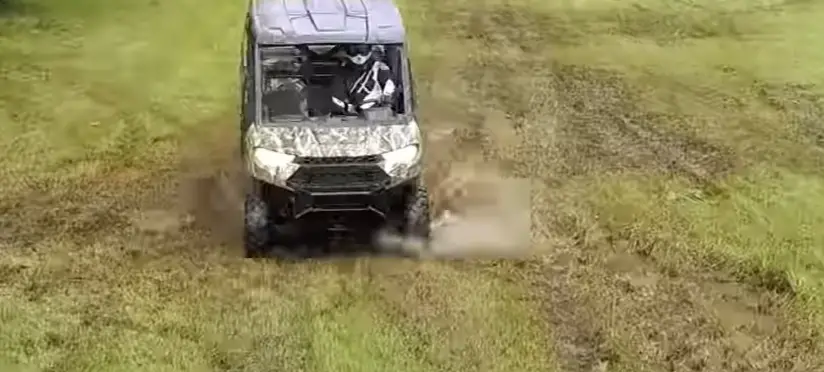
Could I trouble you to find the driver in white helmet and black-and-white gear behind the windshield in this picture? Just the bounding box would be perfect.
[332,45,396,114]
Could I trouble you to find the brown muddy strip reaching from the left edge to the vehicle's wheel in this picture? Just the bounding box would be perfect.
[0,117,242,255]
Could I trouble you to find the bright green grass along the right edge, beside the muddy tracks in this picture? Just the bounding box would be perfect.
[559,2,824,316]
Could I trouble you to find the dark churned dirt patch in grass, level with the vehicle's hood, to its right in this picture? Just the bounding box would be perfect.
[524,65,738,185]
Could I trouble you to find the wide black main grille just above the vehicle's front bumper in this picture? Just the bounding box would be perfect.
[287,165,390,191]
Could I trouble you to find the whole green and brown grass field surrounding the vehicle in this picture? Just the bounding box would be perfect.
[0,0,824,372]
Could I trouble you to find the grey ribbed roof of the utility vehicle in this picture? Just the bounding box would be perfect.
[249,0,405,45]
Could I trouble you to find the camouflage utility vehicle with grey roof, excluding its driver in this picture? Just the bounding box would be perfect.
[240,0,430,257]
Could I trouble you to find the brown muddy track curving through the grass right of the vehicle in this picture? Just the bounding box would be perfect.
[444,59,824,372]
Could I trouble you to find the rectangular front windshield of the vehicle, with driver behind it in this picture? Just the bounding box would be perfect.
[260,44,406,122]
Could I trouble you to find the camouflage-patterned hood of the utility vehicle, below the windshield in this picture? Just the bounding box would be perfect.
[246,120,421,157]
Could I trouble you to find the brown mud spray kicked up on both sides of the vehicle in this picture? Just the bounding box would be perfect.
[179,125,531,258]
